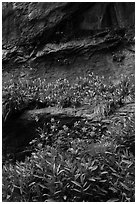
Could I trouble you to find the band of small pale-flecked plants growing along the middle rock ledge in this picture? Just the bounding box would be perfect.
[3,74,135,119]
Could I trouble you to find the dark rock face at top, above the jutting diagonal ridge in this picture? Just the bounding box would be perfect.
[2,2,135,50]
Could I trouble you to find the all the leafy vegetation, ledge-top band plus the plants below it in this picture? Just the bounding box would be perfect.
[2,74,135,202]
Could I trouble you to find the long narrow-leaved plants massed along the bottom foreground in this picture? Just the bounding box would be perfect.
[3,146,134,202]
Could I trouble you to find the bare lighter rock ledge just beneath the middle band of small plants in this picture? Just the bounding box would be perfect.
[19,103,135,121]
